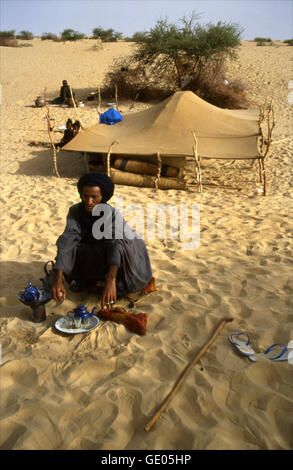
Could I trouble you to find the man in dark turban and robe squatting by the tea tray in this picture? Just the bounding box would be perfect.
[52,173,152,308]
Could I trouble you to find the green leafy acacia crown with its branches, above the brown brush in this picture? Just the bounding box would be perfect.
[132,13,242,88]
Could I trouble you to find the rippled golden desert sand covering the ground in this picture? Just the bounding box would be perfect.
[0,39,293,450]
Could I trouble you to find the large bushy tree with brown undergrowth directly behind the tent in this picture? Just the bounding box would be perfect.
[103,13,246,108]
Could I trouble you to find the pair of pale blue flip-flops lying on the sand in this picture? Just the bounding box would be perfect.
[228,333,289,362]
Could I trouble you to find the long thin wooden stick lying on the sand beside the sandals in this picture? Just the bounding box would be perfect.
[145,318,233,432]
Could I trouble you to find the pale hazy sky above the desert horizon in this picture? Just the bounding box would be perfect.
[0,0,293,40]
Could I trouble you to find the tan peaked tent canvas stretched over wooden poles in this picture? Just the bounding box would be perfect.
[62,91,260,167]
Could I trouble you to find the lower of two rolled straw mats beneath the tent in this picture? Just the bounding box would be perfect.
[110,168,186,189]
